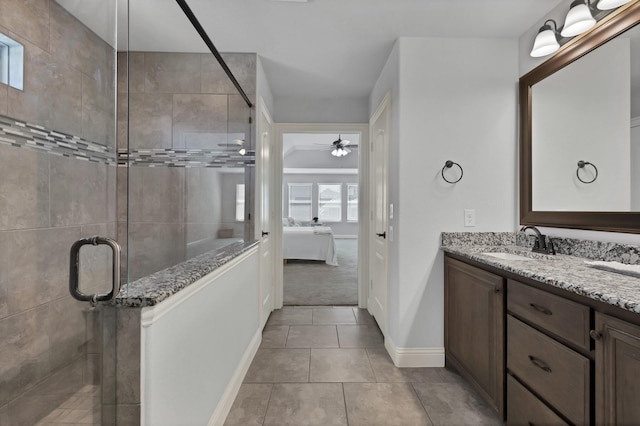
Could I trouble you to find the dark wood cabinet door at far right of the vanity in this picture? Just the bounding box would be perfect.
[595,312,640,425]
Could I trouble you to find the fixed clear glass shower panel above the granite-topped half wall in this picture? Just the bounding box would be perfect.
[118,0,257,288]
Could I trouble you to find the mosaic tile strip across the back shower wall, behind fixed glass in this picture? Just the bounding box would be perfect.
[118,148,256,168]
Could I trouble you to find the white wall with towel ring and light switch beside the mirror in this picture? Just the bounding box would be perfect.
[370,38,518,348]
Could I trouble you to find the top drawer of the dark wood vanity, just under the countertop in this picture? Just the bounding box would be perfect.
[507,280,591,351]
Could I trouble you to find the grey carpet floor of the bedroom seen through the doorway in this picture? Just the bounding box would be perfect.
[283,239,358,306]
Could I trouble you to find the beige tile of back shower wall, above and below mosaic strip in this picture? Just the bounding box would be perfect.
[117,52,256,280]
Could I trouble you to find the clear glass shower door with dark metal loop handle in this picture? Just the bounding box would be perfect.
[0,0,118,426]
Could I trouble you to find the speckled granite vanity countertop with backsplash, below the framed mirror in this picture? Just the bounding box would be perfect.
[442,233,640,314]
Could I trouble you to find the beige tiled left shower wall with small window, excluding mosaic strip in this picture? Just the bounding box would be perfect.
[0,0,116,425]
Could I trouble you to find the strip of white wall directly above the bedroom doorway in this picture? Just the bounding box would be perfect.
[273,97,369,123]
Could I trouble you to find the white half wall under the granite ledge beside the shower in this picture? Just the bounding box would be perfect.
[141,249,260,426]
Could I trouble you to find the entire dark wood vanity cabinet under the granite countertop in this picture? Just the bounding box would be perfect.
[445,255,640,426]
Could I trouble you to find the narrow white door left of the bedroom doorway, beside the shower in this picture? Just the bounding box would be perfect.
[258,99,274,326]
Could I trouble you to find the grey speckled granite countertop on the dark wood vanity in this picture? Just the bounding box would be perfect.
[442,233,640,313]
